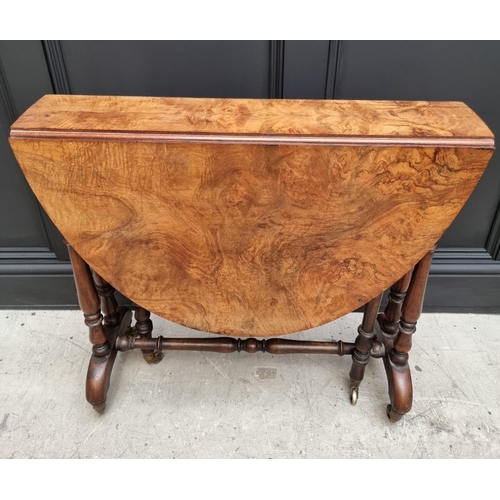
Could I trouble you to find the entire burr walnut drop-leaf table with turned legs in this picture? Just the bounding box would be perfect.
[10,95,494,420]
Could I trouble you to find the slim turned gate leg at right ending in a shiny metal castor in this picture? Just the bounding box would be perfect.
[349,294,382,405]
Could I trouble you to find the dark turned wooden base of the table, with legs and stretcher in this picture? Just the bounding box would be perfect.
[68,245,437,422]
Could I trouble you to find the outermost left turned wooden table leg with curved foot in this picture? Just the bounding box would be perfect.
[68,245,131,413]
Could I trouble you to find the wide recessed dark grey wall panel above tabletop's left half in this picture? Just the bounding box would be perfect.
[61,41,270,98]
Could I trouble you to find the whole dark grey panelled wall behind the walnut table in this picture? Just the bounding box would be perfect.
[0,41,500,313]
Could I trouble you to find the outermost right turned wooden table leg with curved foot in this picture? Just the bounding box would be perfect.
[384,245,437,422]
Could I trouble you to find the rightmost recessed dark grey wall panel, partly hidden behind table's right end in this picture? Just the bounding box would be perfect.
[336,42,500,248]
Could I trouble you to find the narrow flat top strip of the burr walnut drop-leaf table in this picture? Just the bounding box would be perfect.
[11,95,493,147]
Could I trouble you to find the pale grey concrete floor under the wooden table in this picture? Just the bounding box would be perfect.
[0,310,500,458]
